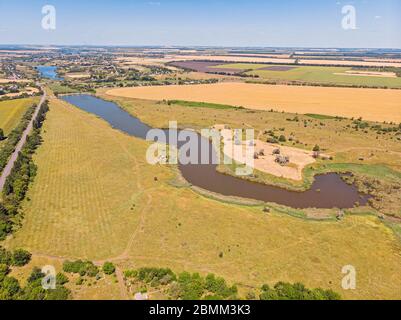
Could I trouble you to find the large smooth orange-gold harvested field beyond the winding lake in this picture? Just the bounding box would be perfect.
[106,83,401,122]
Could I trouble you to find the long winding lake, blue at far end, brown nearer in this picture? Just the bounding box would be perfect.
[62,95,369,208]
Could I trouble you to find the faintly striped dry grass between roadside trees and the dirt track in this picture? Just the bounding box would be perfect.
[5,100,164,258]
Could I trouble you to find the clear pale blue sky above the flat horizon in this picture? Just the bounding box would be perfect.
[0,0,401,48]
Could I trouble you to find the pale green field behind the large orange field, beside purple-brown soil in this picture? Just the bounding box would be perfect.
[215,63,401,88]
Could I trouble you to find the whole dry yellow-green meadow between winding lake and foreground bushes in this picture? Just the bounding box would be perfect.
[5,94,401,299]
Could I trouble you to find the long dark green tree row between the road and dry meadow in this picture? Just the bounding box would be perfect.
[0,101,49,239]
